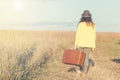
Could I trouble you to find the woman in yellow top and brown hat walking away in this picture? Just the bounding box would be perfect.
[75,10,96,74]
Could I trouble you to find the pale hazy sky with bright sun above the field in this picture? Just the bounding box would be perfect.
[0,0,120,32]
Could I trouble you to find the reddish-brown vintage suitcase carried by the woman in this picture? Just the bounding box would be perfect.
[62,49,85,66]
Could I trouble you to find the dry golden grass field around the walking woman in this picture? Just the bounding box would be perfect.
[0,30,120,80]
